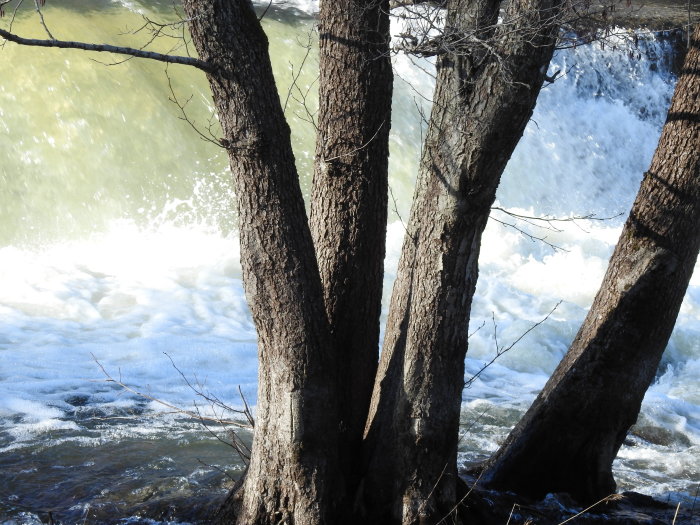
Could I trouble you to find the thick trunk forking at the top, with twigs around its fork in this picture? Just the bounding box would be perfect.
[364,0,559,524]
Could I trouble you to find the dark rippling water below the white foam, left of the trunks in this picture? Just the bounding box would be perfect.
[0,421,249,524]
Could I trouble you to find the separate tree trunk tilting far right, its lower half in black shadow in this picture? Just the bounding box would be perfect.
[481,25,700,503]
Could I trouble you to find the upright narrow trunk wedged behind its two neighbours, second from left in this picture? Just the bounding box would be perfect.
[311,0,393,498]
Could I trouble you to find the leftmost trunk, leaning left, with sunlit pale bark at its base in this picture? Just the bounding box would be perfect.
[184,0,342,525]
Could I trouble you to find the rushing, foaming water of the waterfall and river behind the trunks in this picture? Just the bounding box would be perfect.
[0,0,700,524]
